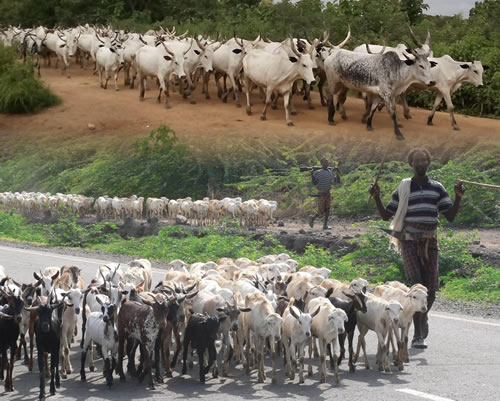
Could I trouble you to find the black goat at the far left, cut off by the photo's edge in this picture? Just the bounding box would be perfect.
[0,287,23,391]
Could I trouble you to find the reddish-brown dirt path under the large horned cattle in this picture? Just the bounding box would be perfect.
[0,65,500,155]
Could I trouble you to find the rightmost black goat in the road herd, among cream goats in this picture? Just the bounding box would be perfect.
[326,289,366,373]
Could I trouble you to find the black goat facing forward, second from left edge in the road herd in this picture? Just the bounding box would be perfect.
[25,297,64,400]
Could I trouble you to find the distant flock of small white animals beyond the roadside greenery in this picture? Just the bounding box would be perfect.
[0,192,278,226]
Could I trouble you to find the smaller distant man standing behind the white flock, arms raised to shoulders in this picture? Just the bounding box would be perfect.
[309,157,340,230]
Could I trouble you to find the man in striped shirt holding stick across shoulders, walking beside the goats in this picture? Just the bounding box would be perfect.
[370,148,465,349]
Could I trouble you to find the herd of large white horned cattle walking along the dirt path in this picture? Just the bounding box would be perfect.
[0,25,487,139]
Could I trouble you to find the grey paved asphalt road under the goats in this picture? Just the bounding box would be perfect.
[0,246,500,401]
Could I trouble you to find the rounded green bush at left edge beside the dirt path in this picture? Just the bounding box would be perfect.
[0,45,60,113]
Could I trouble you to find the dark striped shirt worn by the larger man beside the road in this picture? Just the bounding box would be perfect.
[386,177,452,226]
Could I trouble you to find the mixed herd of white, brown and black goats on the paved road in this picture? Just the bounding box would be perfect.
[0,254,427,399]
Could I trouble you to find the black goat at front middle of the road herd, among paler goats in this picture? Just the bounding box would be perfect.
[182,313,225,383]
